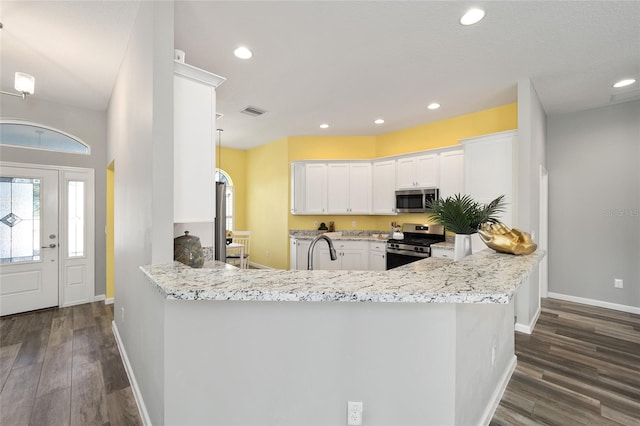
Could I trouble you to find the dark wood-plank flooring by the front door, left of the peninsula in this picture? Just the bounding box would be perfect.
[0,302,142,426]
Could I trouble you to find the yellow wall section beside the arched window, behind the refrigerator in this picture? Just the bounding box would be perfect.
[216,147,248,231]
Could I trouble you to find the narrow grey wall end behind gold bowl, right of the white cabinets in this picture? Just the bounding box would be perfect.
[514,80,546,331]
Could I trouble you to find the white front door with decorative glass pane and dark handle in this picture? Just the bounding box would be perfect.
[0,167,60,315]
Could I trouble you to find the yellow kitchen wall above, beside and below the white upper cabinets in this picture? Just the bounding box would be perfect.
[242,103,518,269]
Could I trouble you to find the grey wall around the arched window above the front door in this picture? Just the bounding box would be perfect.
[0,96,107,295]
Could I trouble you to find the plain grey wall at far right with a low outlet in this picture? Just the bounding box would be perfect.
[547,101,640,311]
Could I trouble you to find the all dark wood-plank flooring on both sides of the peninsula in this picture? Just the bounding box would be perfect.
[0,299,640,426]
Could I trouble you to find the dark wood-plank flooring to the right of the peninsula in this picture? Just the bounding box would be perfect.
[491,299,640,426]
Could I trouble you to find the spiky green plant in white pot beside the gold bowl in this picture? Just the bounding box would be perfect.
[428,194,506,260]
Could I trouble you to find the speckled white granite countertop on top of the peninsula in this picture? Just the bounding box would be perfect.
[141,249,545,303]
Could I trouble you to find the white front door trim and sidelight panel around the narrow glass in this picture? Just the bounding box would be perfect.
[0,161,95,307]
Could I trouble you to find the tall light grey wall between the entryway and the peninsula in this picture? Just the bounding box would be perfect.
[108,2,173,425]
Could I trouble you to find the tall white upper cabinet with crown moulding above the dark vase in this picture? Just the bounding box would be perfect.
[173,62,225,223]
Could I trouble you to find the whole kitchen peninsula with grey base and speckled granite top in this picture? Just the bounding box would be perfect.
[131,249,544,425]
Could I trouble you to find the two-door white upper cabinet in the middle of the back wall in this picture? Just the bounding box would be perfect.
[327,162,372,214]
